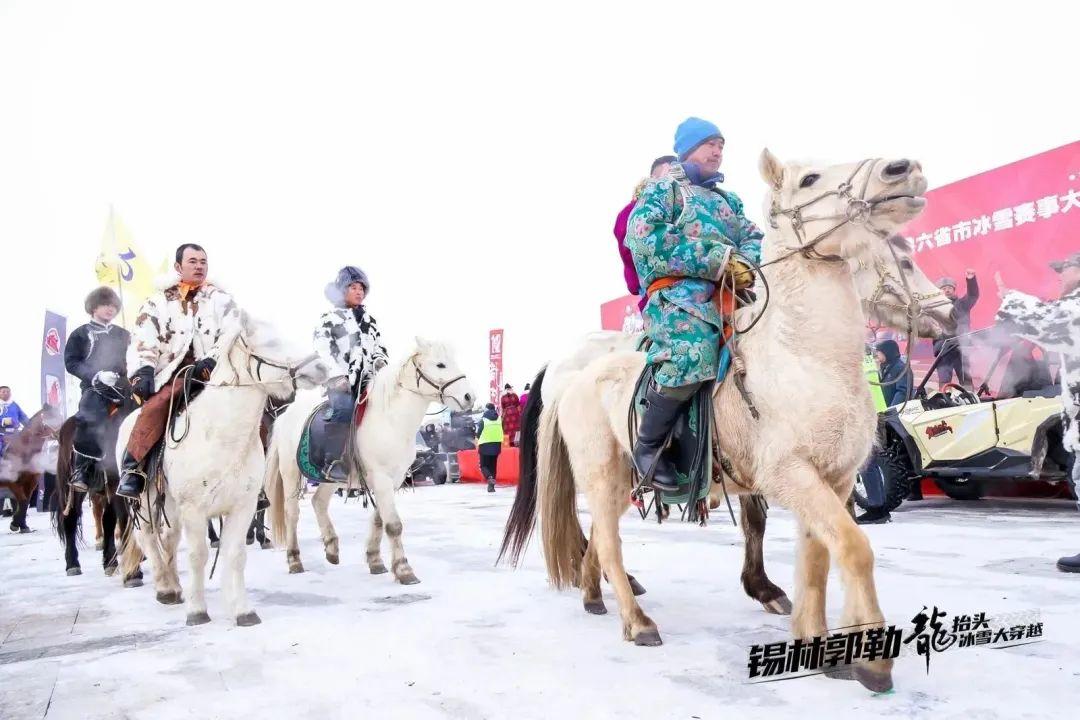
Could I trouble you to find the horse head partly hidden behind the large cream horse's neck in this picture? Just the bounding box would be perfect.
[850,234,956,338]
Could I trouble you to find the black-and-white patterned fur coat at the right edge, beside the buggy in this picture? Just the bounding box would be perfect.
[997,288,1080,452]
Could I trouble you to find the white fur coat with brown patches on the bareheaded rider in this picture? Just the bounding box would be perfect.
[127,273,240,392]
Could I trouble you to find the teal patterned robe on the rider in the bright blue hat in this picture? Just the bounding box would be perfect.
[625,164,762,388]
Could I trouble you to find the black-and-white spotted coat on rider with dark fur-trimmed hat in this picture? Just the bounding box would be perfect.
[315,305,387,388]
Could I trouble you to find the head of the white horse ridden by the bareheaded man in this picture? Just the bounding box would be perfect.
[210,312,329,399]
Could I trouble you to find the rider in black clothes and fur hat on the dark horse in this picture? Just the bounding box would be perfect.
[64,287,131,492]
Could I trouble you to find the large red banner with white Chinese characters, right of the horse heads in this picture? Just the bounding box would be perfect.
[904,141,1080,329]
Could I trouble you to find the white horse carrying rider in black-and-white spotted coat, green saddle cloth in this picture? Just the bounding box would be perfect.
[266,338,476,585]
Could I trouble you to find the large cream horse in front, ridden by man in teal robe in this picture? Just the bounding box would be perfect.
[508,151,946,690]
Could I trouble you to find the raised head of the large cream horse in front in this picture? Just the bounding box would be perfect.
[759,149,927,260]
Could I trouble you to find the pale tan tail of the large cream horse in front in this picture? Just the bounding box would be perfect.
[529,394,583,588]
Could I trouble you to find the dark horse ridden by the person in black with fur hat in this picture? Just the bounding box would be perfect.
[53,406,143,587]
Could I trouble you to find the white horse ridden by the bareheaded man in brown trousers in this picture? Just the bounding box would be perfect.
[117,314,327,625]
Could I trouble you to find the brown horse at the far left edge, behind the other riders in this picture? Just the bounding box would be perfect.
[0,405,64,532]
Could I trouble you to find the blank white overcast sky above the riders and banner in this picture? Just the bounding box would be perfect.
[0,0,1080,409]
